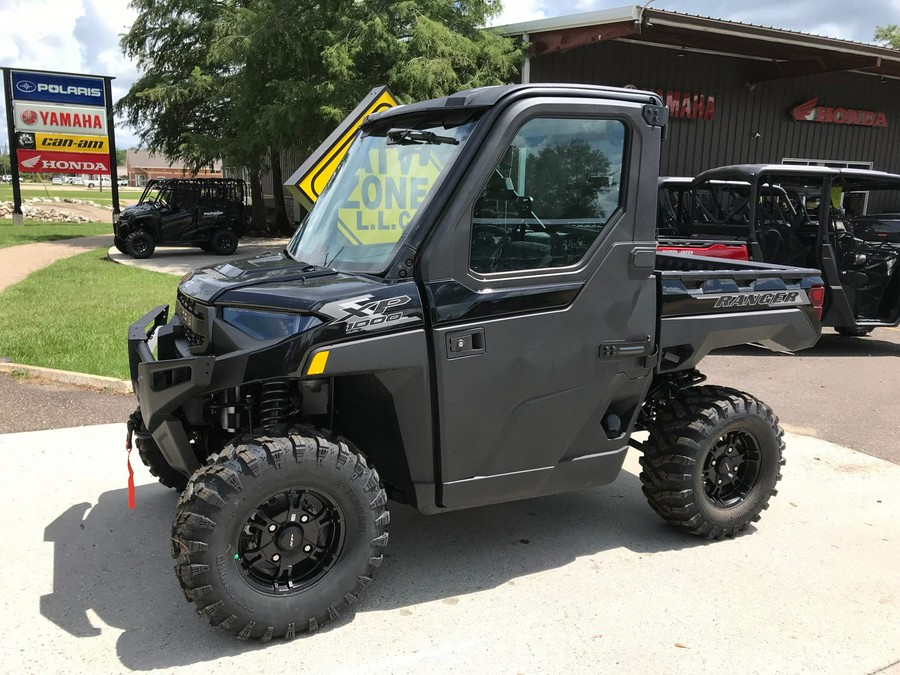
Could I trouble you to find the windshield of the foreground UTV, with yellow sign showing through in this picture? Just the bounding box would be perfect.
[287,118,475,274]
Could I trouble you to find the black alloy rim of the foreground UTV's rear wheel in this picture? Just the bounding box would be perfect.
[703,431,762,508]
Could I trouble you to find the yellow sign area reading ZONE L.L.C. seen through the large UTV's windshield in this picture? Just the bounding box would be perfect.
[337,145,446,246]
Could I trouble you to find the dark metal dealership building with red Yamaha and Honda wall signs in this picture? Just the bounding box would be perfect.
[500,6,900,176]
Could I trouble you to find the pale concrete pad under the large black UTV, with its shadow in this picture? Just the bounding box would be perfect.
[0,424,900,675]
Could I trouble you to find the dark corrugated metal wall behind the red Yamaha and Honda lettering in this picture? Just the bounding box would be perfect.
[531,42,900,211]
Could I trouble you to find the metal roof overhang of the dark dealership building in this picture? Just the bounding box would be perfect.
[499,6,900,84]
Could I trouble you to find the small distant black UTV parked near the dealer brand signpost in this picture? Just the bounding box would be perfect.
[113,178,247,258]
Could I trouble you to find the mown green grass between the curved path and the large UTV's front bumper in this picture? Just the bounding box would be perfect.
[0,250,178,379]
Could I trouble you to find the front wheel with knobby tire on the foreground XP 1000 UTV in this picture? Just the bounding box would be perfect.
[172,429,390,642]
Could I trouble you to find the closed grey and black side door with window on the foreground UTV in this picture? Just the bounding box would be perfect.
[422,99,659,507]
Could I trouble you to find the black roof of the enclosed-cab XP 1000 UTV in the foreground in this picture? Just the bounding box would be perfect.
[363,83,662,127]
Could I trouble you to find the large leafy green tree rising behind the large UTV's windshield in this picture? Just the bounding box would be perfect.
[119,0,523,231]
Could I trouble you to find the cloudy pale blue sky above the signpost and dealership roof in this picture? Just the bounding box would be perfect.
[0,0,900,154]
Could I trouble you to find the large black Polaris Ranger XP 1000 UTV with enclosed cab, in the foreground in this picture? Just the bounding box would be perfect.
[128,85,824,641]
